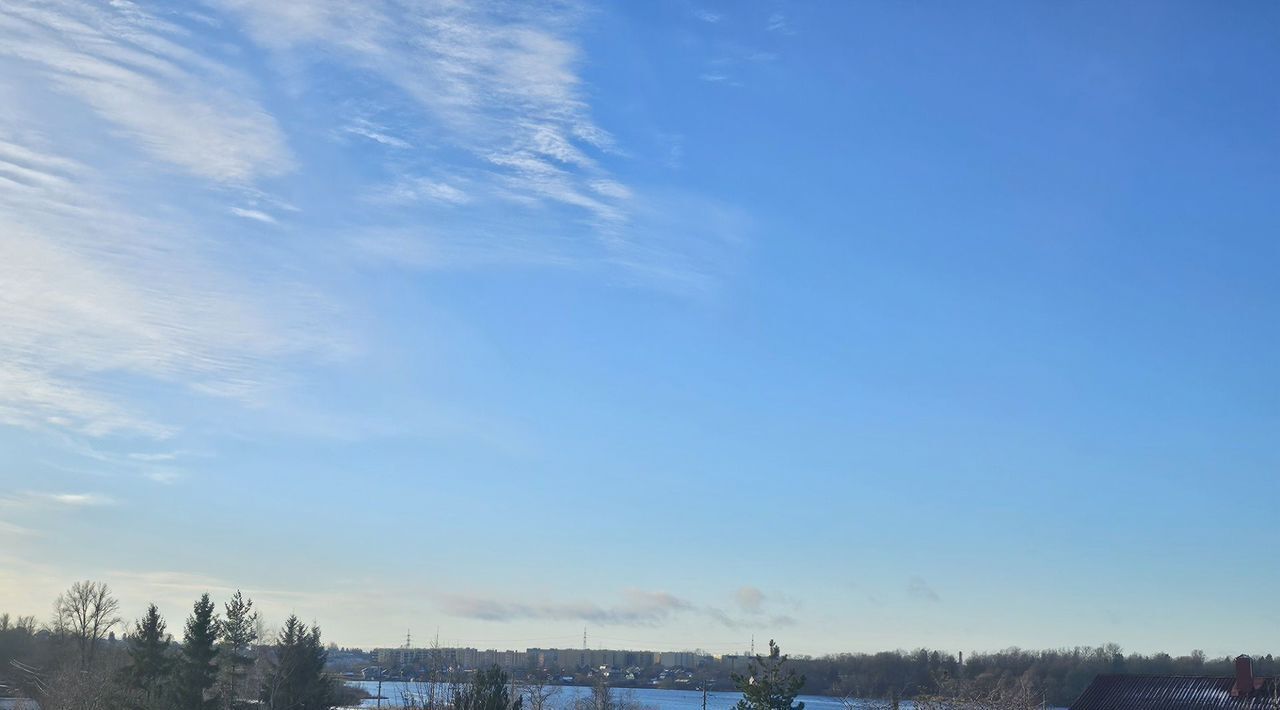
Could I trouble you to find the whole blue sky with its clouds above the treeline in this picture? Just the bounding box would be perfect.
[0,0,1280,654]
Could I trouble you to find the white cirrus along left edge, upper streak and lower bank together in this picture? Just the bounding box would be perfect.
[0,0,345,438]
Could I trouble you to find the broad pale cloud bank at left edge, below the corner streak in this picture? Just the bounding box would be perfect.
[0,125,340,438]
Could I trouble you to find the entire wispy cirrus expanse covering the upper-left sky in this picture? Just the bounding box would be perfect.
[0,0,748,450]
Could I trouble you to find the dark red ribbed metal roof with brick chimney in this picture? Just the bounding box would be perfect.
[1070,656,1280,710]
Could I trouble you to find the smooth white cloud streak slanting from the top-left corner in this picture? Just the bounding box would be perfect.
[0,0,292,183]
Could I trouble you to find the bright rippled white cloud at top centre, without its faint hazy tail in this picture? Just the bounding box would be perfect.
[215,0,650,236]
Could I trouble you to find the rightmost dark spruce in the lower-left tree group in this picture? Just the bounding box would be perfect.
[261,617,335,710]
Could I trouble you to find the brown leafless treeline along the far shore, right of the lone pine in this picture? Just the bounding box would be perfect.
[792,643,1280,706]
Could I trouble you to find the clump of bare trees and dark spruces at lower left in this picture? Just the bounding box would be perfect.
[0,582,351,710]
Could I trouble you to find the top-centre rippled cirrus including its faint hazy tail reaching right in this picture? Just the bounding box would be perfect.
[212,0,747,290]
